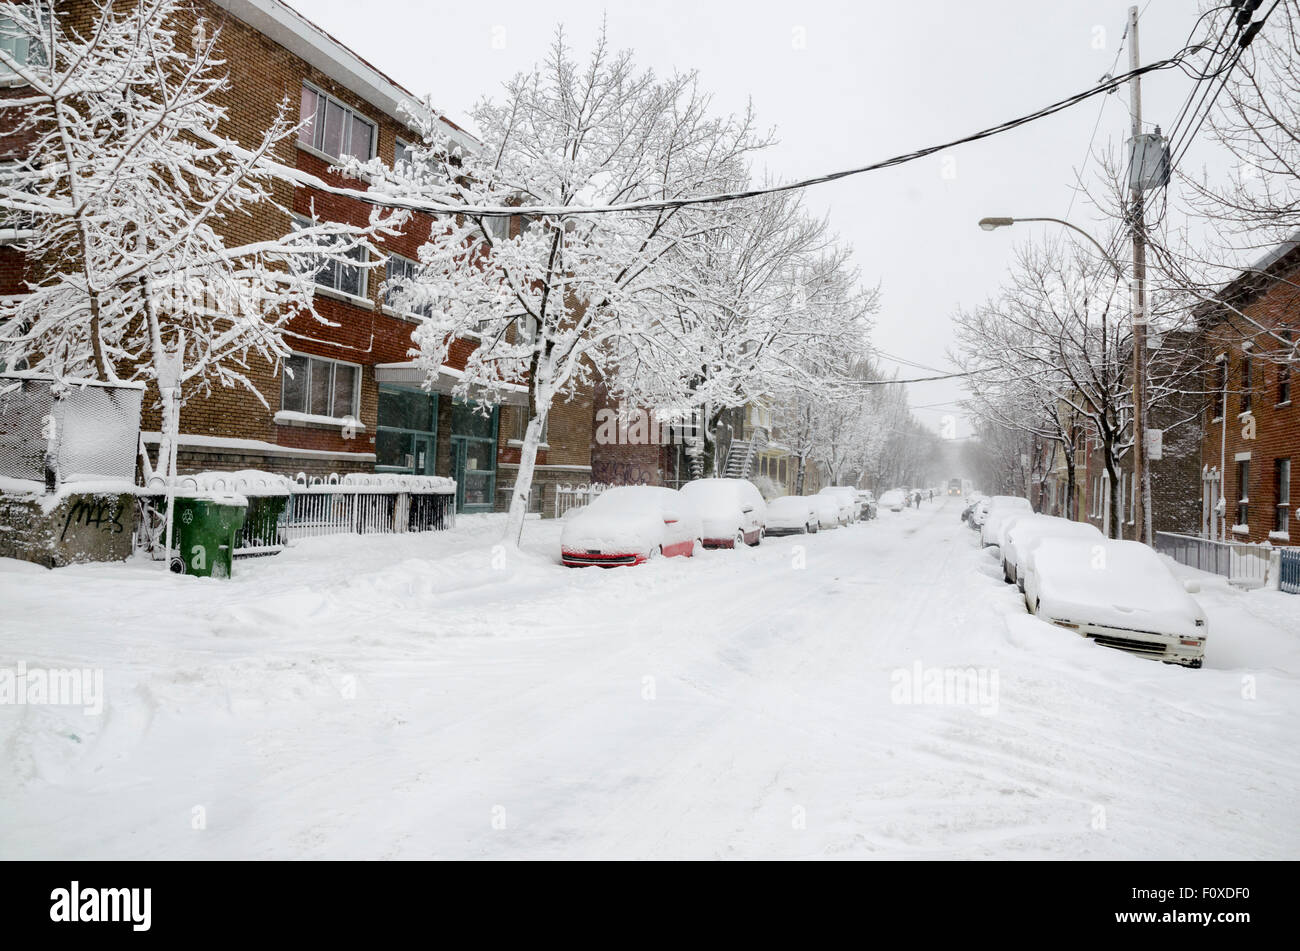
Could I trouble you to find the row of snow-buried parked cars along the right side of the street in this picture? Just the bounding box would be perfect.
[967,496,1206,668]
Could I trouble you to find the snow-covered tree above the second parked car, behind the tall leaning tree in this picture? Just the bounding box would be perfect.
[612,192,879,474]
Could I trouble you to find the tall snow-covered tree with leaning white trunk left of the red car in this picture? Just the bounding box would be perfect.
[365,27,762,544]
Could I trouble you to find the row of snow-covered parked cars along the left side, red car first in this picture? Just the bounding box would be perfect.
[560,478,876,568]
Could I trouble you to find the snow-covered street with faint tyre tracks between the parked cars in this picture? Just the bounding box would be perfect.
[0,500,1300,859]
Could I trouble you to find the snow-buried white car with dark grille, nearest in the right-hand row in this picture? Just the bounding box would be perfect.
[1026,538,1206,666]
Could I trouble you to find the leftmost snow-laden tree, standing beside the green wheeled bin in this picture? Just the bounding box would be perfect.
[0,0,402,473]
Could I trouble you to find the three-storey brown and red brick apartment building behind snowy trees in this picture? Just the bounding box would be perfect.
[0,0,593,511]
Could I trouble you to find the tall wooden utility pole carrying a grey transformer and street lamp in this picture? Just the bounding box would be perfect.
[1121,6,1152,544]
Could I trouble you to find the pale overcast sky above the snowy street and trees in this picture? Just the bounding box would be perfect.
[293,0,1219,437]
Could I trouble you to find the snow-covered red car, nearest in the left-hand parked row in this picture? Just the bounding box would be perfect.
[560,486,703,568]
